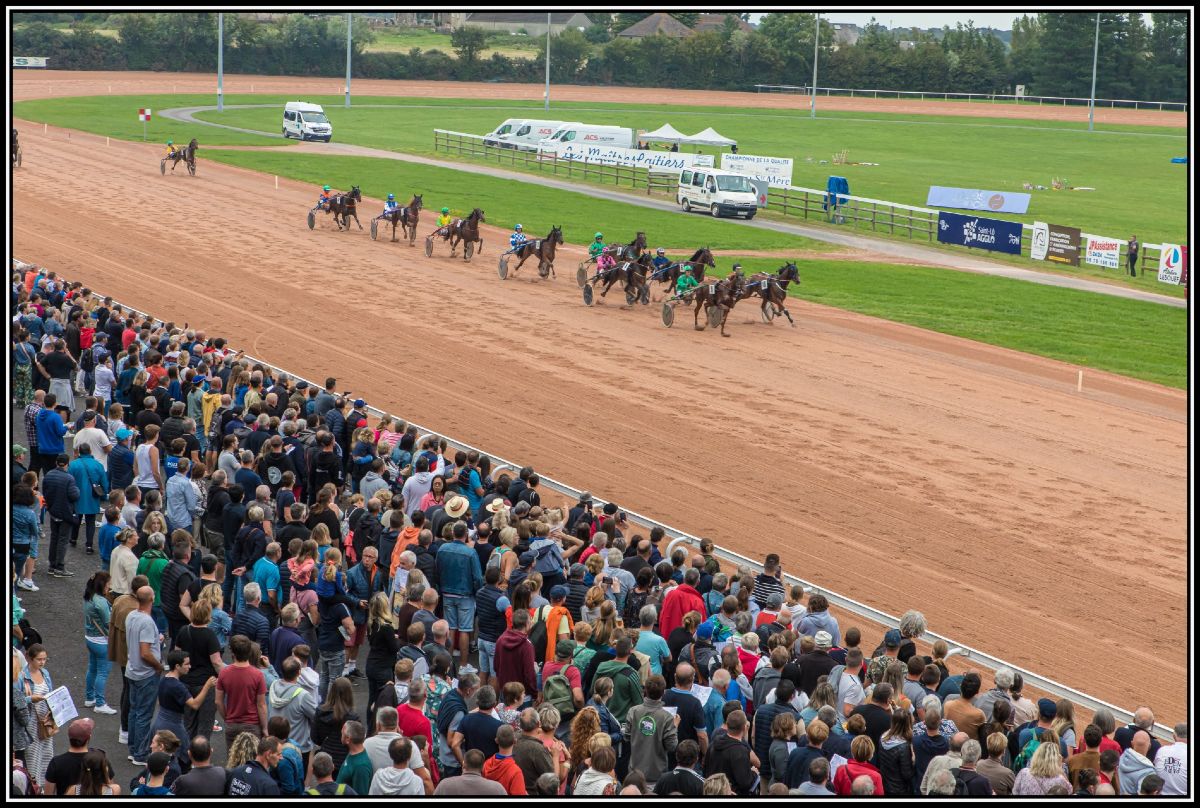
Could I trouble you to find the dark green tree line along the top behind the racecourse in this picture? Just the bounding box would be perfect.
[12,12,1188,101]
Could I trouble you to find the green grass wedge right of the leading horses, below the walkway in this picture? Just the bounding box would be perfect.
[715,258,1188,389]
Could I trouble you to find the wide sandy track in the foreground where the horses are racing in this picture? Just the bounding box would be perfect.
[13,124,1188,720]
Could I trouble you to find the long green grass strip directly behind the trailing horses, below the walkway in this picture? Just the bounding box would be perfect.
[204,149,817,250]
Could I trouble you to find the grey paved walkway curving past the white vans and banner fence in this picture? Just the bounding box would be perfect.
[158,104,1187,309]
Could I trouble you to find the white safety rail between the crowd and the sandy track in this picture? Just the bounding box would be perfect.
[12,258,1172,740]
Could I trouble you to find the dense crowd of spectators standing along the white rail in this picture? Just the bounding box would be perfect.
[10,267,1189,796]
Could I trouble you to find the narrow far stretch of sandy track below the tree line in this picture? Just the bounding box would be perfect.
[12,70,1187,127]
